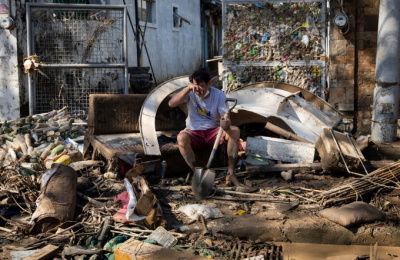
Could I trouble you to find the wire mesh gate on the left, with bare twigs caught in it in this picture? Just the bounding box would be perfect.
[27,3,128,116]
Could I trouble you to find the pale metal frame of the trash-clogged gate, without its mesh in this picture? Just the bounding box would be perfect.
[222,0,328,97]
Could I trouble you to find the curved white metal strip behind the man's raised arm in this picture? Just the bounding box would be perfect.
[139,76,190,155]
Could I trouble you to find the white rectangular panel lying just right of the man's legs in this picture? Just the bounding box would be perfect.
[246,136,315,163]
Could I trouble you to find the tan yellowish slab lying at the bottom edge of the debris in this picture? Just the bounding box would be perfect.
[114,239,209,260]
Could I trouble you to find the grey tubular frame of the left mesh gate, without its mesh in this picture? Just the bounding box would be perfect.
[26,3,129,115]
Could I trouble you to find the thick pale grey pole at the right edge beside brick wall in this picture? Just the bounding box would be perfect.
[371,0,400,142]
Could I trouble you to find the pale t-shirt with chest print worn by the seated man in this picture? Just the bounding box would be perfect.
[186,87,226,130]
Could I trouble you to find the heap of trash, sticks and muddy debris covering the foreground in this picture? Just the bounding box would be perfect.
[0,109,400,260]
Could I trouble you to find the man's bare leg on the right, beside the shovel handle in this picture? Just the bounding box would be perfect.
[225,126,242,186]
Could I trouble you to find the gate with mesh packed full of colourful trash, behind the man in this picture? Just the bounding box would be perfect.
[223,0,326,97]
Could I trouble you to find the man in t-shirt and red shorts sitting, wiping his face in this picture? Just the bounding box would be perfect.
[168,70,240,186]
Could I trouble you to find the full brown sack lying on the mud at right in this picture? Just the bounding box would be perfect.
[318,201,385,227]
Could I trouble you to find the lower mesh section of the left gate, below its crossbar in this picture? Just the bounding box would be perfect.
[34,68,125,117]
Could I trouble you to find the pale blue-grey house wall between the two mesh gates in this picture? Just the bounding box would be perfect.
[123,0,202,84]
